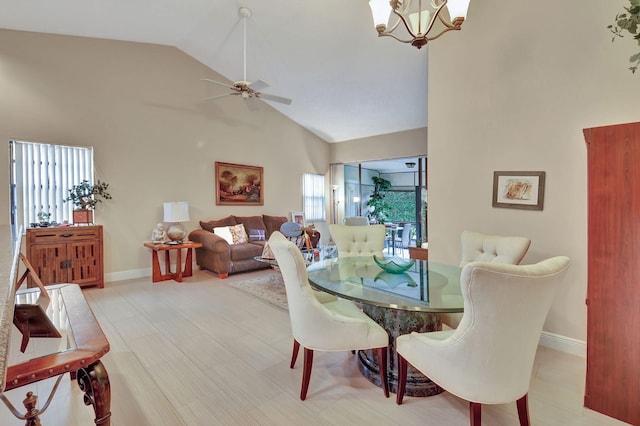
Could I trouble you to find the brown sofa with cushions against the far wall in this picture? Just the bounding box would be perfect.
[189,215,320,278]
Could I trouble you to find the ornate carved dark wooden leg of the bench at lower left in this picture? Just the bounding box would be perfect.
[77,361,111,426]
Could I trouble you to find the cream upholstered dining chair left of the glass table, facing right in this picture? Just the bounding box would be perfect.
[269,231,389,401]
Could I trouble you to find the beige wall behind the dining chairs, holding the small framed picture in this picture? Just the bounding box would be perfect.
[428,0,640,340]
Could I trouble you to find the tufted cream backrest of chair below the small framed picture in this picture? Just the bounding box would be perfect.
[460,231,531,266]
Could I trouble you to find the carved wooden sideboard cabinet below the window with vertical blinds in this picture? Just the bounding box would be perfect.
[26,225,104,288]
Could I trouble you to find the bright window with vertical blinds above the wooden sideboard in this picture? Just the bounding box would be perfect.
[9,141,93,228]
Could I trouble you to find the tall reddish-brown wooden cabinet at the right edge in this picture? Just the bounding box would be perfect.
[584,123,640,425]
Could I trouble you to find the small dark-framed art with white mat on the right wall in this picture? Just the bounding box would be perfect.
[492,172,545,210]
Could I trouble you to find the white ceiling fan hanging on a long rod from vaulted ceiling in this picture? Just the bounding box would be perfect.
[202,7,291,111]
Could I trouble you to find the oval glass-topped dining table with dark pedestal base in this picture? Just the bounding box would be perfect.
[307,256,464,396]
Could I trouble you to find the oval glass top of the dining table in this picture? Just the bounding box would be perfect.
[307,256,464,312]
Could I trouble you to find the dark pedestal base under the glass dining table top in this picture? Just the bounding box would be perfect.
[358,304,444,396]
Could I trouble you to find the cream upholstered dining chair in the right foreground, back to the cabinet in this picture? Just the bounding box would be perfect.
[396,256,569,426]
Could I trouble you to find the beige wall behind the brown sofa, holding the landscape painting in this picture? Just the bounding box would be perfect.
[0,31,329,279]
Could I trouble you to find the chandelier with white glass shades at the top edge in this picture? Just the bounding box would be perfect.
[369,0,470,49]
